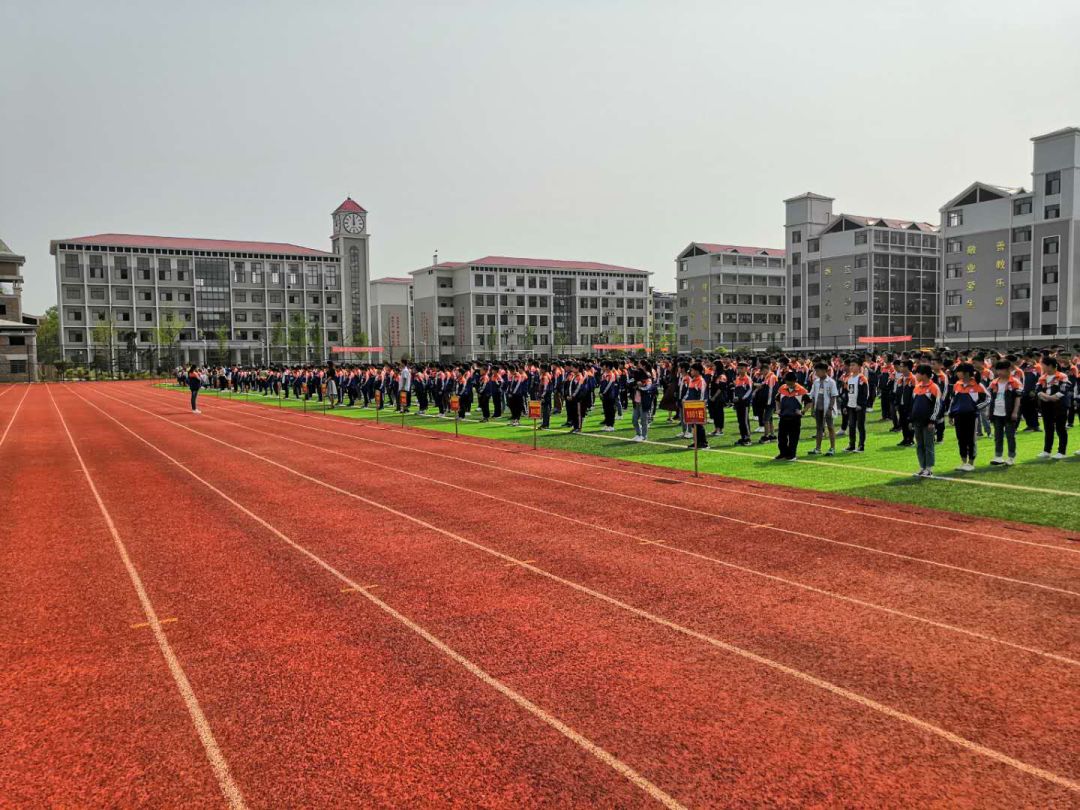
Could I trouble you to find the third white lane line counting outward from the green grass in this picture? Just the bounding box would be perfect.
[181,403,1080,666]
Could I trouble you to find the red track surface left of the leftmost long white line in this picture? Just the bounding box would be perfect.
[0,387,222,807]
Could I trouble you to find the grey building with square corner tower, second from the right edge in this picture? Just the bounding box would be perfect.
[784,192,941,348]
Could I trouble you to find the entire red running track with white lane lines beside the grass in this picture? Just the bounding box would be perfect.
[0,383,1080,807]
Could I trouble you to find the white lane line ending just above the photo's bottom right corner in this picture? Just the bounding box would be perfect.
[84,386,1080,793]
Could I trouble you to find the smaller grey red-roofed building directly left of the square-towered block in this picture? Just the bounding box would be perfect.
[675,242,787,351]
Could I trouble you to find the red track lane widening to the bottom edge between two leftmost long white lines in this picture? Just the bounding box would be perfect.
[57,392,662,807]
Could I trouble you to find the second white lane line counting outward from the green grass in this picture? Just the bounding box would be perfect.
[137,394,1080,597]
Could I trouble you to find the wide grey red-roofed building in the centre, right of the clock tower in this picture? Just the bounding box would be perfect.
[411,256,649,361]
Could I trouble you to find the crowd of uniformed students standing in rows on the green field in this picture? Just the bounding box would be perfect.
[177,348,1080,476]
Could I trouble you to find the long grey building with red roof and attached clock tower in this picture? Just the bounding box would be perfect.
[50,198,370,364]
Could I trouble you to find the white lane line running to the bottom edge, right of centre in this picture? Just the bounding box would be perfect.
[79,384,683,810]
